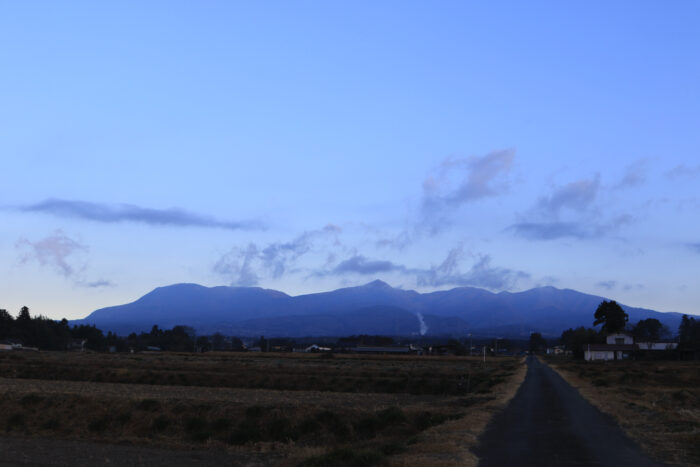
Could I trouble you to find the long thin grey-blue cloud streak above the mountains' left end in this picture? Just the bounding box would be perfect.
[19,198,263,230]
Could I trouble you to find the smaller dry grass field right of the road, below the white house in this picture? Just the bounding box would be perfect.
[547,359,700,466]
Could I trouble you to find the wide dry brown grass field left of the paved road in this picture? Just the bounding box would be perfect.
[0,352,525,466]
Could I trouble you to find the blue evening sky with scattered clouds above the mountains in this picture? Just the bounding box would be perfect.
[0,0,700,319]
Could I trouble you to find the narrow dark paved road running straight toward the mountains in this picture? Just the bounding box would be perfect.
[475,357,659,467]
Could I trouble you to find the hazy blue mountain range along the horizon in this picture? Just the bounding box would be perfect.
[71,280,682,338]
